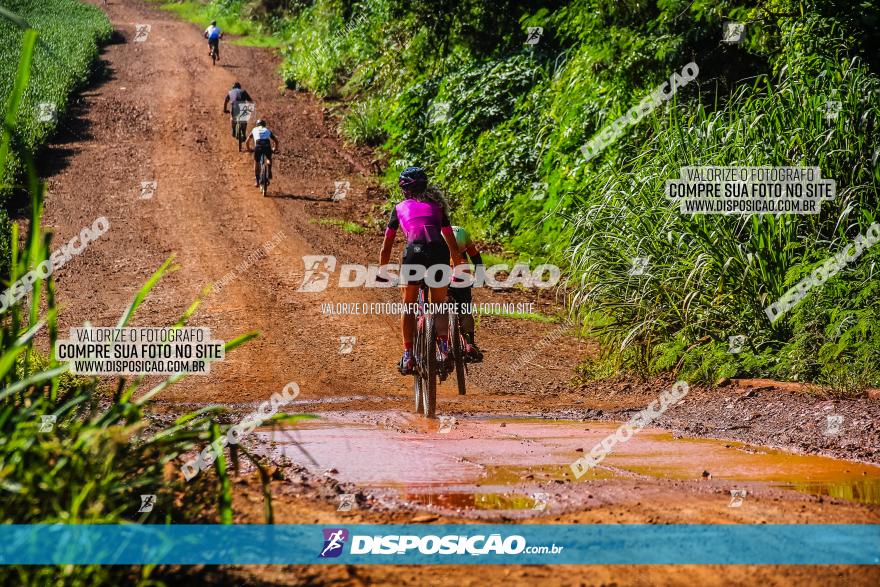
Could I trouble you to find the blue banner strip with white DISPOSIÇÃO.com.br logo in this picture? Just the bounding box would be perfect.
[0,524,880,565]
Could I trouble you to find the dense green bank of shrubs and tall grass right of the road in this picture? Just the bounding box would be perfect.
[191,0,880,391]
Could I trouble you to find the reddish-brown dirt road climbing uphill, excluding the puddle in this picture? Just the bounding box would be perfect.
[37,0,880,585]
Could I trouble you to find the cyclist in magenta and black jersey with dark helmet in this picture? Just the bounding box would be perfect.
[379,167,460,375]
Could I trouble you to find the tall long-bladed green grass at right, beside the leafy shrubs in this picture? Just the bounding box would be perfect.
[571,13,880,387]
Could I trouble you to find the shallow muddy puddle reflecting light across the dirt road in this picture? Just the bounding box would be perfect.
[257,414,880,512]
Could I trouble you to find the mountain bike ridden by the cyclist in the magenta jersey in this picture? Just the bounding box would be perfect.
[413,282,454,418]
